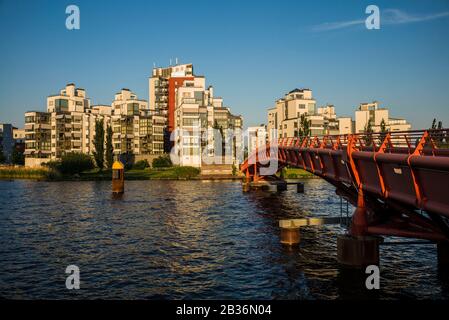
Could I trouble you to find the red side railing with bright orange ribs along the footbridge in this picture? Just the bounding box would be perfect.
[241,129,449,216]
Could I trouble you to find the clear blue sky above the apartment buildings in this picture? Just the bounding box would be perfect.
[0,0,449,128]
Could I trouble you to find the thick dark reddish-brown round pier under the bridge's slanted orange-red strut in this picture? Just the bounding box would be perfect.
[337,235,381,268]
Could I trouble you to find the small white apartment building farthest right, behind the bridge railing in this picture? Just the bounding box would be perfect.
[355,101,411,133]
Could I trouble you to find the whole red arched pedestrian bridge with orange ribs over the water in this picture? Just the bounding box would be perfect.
[240,129,449,252]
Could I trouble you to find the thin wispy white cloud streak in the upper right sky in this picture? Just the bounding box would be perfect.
[311,9,449,32]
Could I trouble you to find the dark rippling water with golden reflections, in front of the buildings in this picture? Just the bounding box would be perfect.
[0,179,449,299]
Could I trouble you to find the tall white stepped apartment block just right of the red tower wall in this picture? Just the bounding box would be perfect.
[172,77,243,167]
